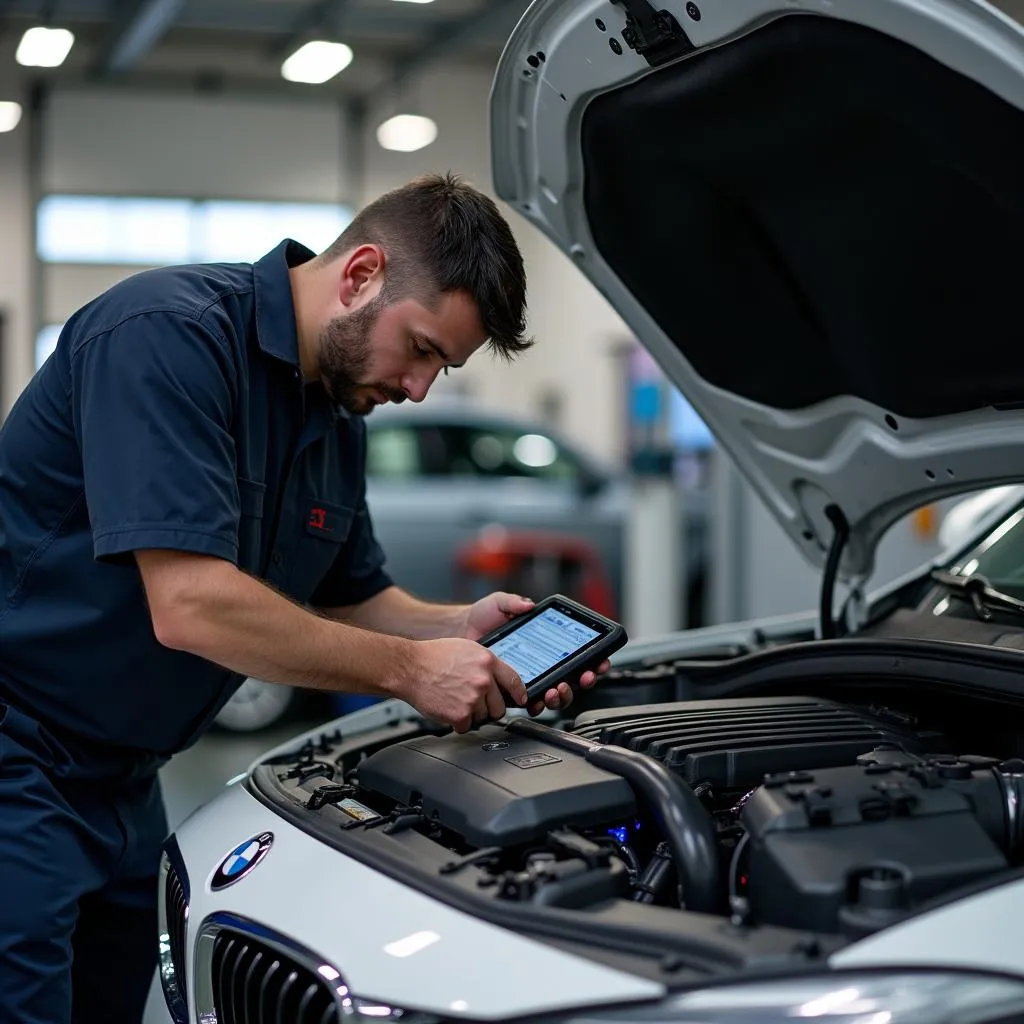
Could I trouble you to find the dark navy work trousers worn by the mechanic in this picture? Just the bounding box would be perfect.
[0,698,167,1024]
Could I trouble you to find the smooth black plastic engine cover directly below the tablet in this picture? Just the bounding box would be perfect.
[358,725,637,847]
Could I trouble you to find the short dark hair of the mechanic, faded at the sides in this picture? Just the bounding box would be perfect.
[321,172,534,359]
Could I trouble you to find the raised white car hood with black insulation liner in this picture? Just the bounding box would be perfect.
[490,0,1024,584]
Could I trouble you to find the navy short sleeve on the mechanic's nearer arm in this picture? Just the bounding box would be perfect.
[71,312,239,561]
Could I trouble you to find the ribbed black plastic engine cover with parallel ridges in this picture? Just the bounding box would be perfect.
[573,697,944,788]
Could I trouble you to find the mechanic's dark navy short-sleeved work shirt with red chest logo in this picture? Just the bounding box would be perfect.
[0,241,391,760]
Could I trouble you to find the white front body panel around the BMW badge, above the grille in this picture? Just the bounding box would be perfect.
[169,782,665,1020]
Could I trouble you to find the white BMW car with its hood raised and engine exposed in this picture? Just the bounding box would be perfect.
[153,0,1024,1024]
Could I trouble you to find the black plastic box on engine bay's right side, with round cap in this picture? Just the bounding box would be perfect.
[741,758,1008,935]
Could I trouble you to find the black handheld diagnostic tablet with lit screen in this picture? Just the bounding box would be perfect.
[480,594,628,700]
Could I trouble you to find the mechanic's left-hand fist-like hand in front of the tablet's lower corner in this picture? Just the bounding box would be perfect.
[396,639,526,732]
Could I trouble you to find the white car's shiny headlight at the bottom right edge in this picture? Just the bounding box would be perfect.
[560,971,1024,1024]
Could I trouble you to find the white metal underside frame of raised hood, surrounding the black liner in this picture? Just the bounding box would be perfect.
[492,0,1024,582]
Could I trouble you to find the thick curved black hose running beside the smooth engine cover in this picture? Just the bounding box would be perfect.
[506,717,722,913]
